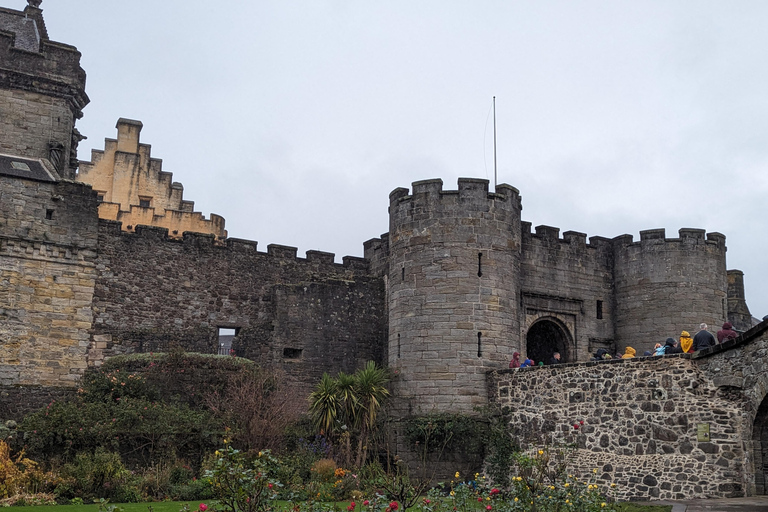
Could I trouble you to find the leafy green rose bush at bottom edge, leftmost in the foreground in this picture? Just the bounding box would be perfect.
[205,445,281,512]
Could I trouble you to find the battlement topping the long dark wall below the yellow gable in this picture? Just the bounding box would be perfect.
[99,219,370,273]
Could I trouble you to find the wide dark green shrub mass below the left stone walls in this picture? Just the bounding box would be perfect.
[22,362,223,466]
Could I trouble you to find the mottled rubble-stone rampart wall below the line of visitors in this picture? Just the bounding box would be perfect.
[489,355,754,499]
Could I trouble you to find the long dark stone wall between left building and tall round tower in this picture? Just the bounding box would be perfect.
[89,220,386,396]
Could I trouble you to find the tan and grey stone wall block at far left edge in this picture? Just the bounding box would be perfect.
[0,176,97,387]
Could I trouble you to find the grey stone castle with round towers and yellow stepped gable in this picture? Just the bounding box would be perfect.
[0,0,768,496]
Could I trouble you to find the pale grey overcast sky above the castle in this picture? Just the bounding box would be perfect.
[37,0,768,317]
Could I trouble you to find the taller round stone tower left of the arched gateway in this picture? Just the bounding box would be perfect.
[388,178,521,415]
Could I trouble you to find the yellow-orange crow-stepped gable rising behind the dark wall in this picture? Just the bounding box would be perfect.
[77,118,227,239]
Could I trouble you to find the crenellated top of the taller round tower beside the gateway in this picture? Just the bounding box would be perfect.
[389,178,521,209]
